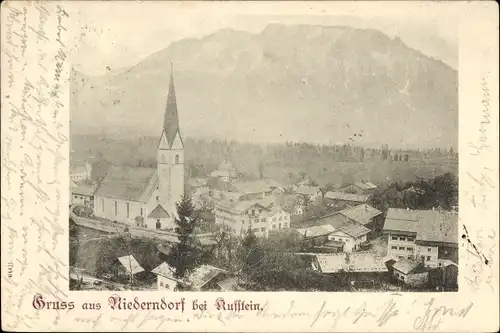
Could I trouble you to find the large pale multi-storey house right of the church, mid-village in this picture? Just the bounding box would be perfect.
[215,197,290,237]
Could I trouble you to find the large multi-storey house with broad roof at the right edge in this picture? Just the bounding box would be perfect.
[383,208,458,267]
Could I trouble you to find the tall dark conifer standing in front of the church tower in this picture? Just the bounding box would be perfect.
[167,196,203,279]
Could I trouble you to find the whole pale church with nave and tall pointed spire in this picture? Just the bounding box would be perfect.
[94,69,184,230]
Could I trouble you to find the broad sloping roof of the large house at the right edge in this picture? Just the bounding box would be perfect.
[384,208,458,244]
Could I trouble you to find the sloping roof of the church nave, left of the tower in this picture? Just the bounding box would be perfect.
[95,166,158,202]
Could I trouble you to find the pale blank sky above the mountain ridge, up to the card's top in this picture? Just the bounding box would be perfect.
[71,1,463,75]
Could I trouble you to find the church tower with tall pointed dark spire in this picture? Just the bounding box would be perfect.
[157,65,184,216]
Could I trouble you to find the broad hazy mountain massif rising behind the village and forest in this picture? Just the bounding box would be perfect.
[70,24,458,147]
